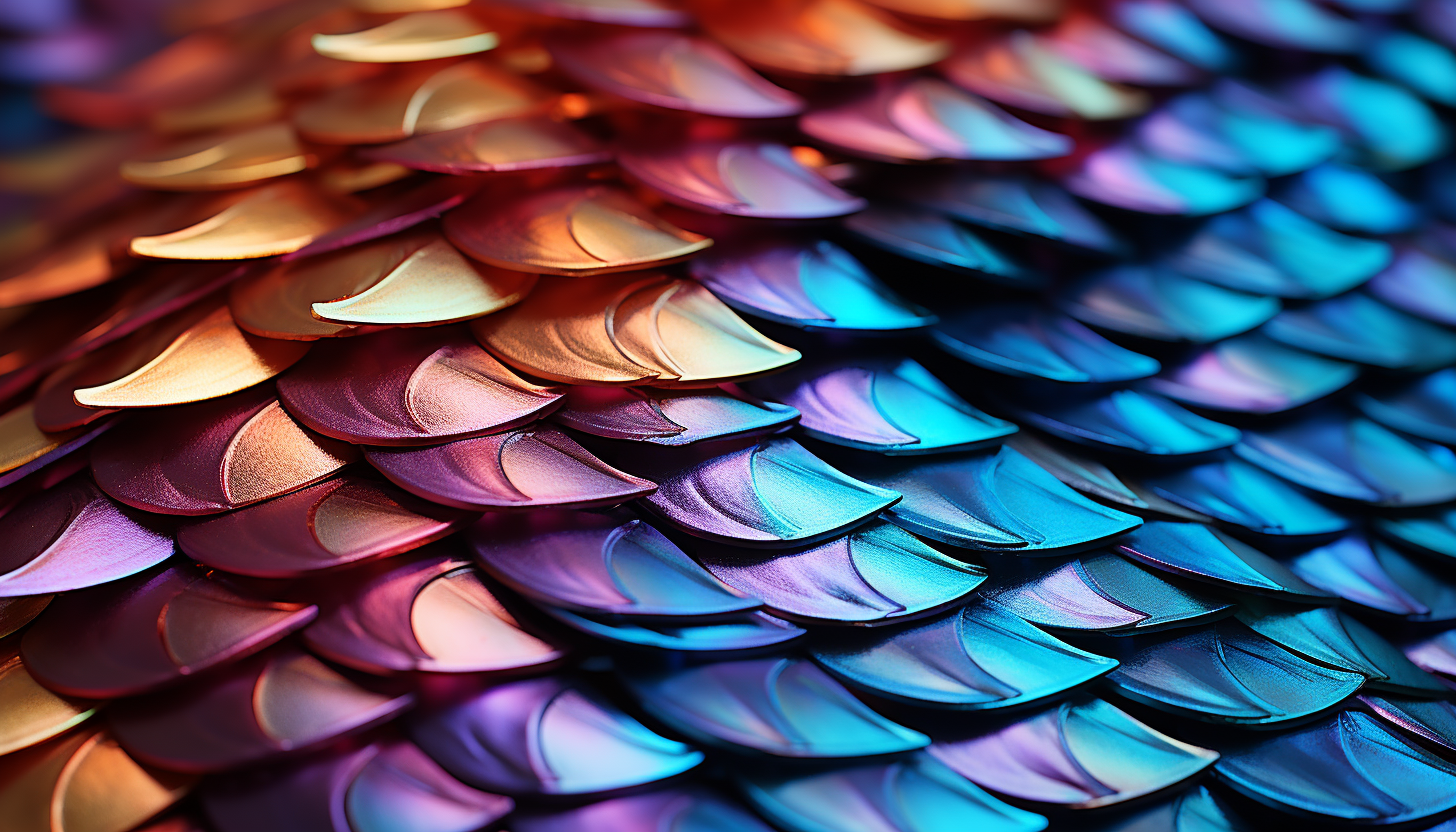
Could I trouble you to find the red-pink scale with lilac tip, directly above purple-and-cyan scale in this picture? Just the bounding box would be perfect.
[617,141,868,220]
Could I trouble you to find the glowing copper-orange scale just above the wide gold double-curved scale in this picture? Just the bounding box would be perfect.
[444,185,712,277]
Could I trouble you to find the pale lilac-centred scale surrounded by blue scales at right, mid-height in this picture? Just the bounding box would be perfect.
[1146,332,1360,414]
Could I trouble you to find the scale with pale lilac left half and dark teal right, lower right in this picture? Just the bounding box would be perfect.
[986,552,1233,634]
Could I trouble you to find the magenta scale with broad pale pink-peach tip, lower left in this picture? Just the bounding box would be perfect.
[303,555,565,673]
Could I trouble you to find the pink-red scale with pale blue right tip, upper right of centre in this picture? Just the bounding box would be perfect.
[799,77,1072,162]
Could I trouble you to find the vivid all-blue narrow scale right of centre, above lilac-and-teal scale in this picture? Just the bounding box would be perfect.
[1143,459,1350,538]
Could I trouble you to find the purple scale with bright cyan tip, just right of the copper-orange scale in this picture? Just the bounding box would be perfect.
[689,238,935,334]
